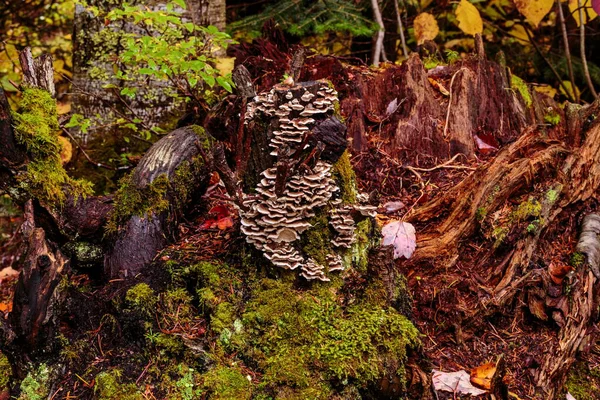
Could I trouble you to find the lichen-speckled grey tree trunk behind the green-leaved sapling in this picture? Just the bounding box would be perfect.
[72,0,225,148]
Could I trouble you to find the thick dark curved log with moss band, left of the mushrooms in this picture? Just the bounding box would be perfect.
[105,127,213,277]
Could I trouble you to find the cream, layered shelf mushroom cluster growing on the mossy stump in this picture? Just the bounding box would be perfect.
[241,83,374,281]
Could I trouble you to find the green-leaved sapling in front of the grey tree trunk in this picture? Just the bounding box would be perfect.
[79,0,234,139]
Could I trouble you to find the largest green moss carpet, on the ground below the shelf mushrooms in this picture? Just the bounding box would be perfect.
[241,279,418,398]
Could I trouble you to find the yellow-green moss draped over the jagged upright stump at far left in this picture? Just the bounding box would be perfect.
[13,88,92,206]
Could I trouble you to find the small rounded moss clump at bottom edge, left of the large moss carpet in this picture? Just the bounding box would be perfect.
[203,366,252,400]
